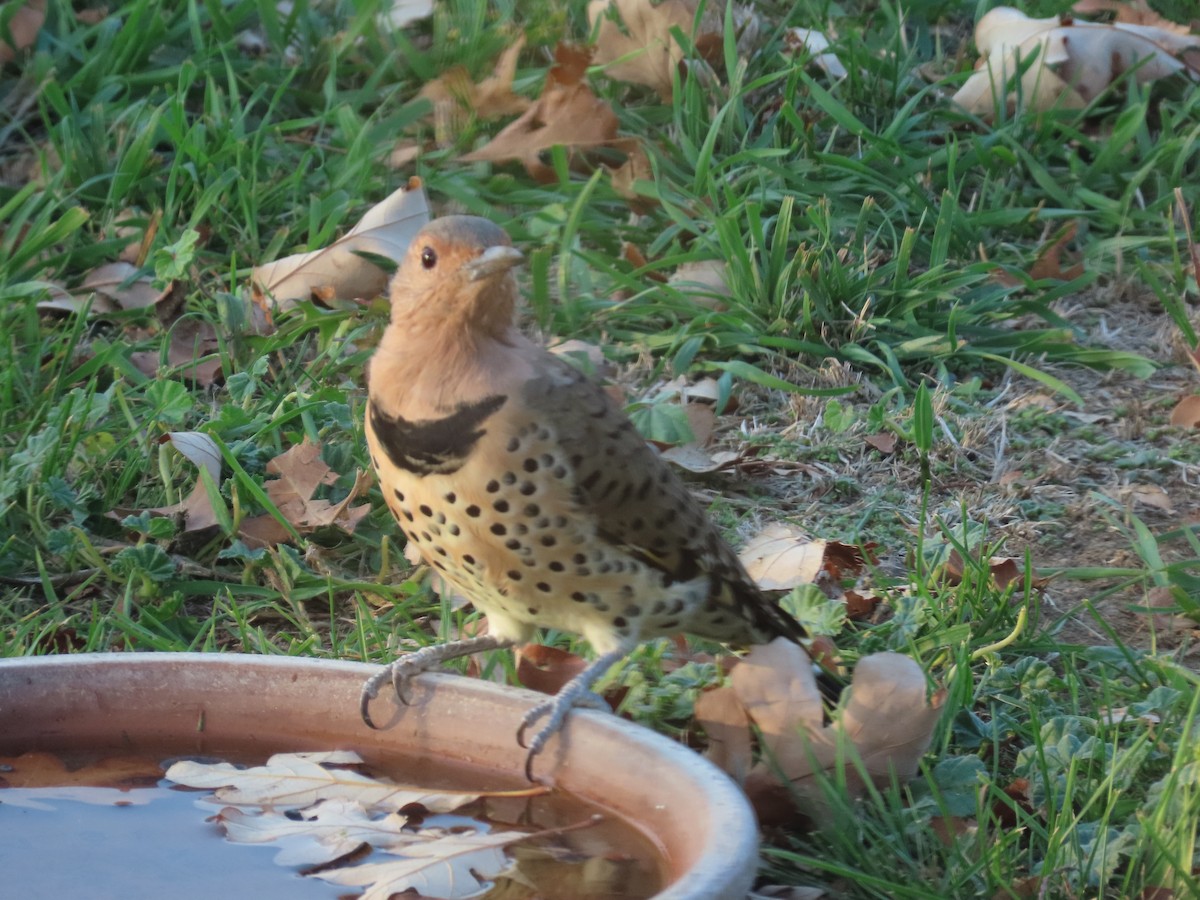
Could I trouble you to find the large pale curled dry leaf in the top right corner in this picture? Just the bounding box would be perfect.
[953,6,1200,119]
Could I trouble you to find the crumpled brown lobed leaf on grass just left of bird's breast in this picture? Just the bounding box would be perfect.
[240,440,371,546]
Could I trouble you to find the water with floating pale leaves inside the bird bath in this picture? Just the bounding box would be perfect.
[0,750,666,900]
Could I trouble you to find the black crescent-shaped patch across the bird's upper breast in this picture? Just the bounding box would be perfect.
[367,394,508,476]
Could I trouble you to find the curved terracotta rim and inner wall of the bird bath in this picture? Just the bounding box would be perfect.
[0,653,758,900]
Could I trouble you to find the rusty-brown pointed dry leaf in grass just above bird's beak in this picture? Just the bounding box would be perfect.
[462,43,629,182]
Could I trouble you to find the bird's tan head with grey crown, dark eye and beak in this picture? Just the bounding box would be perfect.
[391,216,524,337]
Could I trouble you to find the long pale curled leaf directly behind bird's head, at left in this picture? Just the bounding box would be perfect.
[251,179,430,310]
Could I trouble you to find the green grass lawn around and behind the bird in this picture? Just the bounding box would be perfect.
[0,0,1200,898]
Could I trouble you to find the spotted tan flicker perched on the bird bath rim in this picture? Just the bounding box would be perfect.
[360,216,806,781]
